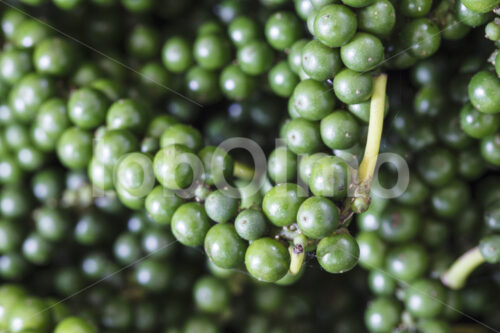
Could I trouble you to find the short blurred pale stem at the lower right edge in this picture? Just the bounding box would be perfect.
[441,246,484,289]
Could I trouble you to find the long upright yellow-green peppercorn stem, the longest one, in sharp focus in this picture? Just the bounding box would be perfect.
[358,74,387,186]
